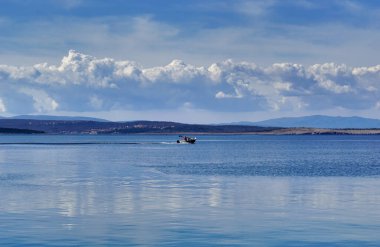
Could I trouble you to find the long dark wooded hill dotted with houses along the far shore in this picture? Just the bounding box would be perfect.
[0,118,279,134]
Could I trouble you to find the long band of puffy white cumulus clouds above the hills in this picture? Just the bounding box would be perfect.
[0,50,380,116]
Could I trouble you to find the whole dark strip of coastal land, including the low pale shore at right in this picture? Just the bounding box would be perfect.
[0,119,380,135]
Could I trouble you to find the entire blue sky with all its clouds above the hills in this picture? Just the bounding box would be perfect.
[0,0,380,123]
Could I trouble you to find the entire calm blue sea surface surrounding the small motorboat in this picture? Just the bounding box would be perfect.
[0,135,380,246]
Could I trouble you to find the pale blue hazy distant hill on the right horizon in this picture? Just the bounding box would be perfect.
[246,115,380,129]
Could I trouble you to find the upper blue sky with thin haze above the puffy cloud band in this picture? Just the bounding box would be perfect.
[0,0,380,66]
